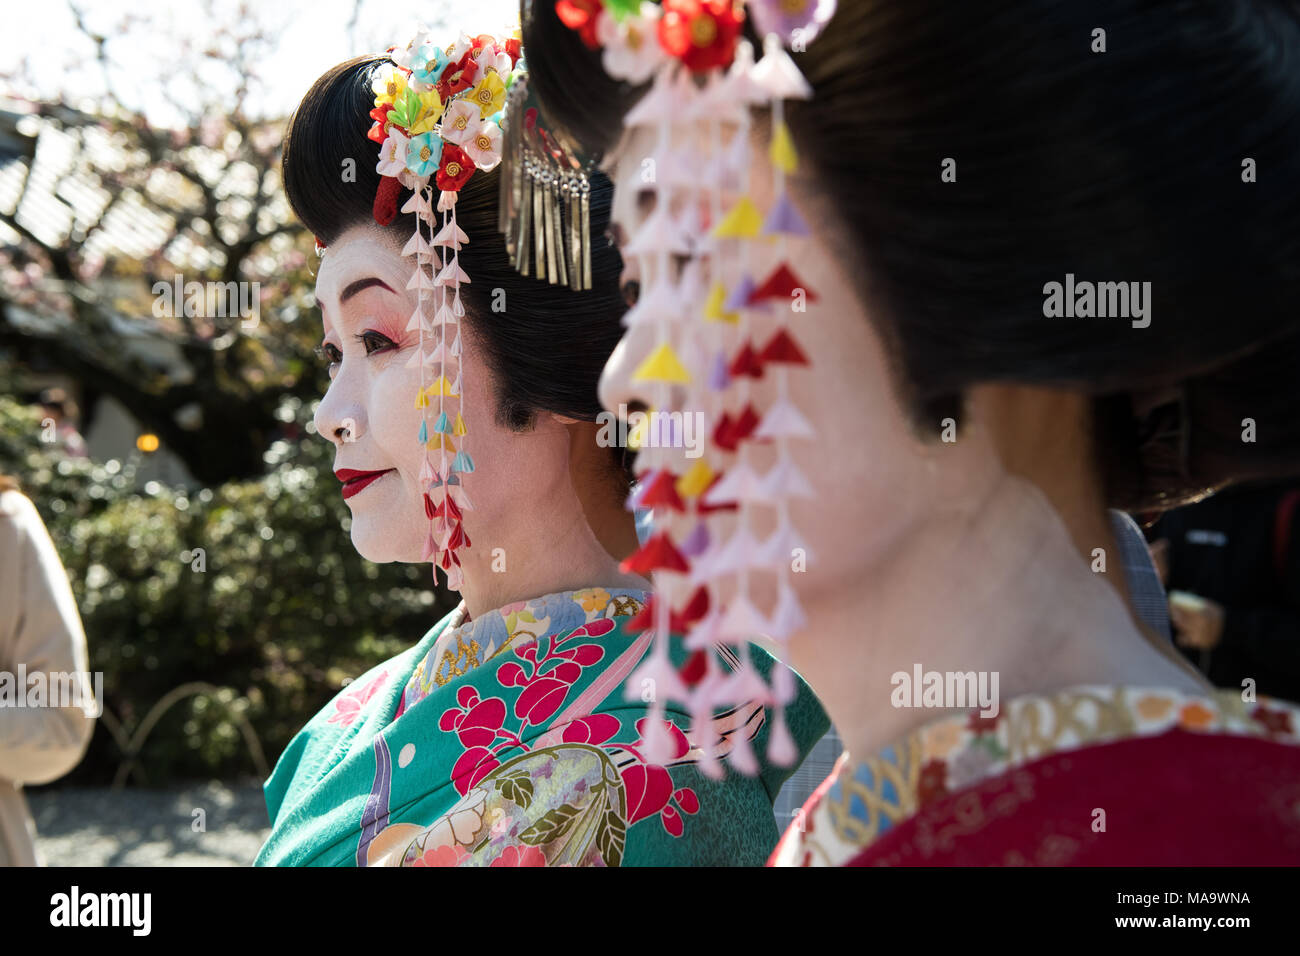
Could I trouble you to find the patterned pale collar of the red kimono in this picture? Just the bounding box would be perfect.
[768,685,1300,866]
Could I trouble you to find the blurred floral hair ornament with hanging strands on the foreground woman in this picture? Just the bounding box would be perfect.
[555,0,835,777]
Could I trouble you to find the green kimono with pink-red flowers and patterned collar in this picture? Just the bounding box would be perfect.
[256,588,828,866]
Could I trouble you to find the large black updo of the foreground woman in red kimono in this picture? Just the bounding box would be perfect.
[520,0,1300,510]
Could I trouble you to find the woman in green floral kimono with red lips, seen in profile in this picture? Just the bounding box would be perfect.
[248,35,827,866]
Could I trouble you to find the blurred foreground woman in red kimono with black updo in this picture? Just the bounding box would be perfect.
[521,0,1300,865]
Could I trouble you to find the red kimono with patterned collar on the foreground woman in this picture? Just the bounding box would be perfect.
[768,687,1300,866]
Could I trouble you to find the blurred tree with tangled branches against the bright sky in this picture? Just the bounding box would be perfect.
[0,0,322,484]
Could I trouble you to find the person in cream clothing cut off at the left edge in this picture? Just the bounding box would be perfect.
[0,476,98,866]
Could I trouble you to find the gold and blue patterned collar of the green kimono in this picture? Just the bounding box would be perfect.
[397,588,650,717]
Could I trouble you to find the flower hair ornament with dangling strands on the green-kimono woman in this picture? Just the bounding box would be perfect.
[345,29,521,591]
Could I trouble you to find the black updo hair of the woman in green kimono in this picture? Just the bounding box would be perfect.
[281,55,627,492]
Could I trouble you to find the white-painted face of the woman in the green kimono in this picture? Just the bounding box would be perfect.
[316,225,568,562]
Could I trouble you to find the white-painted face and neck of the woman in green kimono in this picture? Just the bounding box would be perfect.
[315,225,645,617]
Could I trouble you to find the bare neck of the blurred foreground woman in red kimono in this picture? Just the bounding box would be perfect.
[792,471,1209,758]
